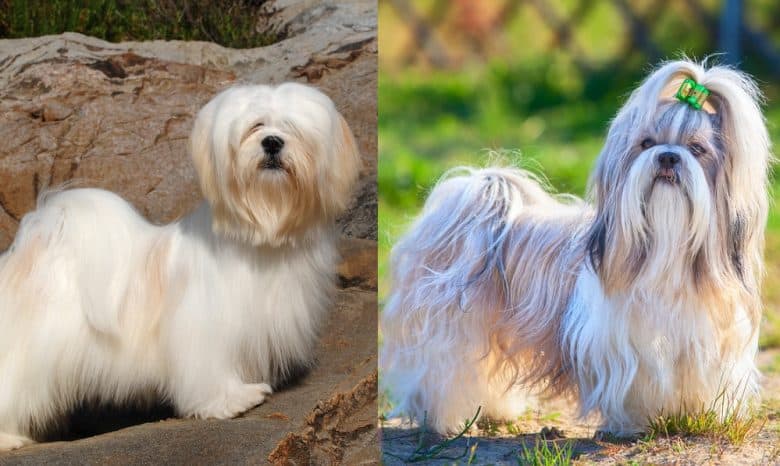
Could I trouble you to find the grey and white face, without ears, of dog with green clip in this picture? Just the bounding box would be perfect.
[615,101,726,258]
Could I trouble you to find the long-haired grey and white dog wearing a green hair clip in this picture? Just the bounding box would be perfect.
[380,61,771,435]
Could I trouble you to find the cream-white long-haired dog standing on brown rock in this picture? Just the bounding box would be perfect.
[0,83,360,450]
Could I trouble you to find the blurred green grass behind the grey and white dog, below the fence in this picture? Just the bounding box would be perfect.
[378,62,780,346]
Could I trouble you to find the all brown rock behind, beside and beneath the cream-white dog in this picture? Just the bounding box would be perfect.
[0,0,378,464]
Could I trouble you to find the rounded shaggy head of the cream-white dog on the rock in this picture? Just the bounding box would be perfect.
[191,83,360,245]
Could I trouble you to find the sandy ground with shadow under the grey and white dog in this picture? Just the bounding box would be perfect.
[380,349,780,465]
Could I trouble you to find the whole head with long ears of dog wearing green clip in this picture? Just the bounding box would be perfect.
[588,61,771,306]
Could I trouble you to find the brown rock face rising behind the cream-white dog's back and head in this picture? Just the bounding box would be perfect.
[0,0,377,250]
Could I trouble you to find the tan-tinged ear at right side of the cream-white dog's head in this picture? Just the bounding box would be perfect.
[321,112,362,215]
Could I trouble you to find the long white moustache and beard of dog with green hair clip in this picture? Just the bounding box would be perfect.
[602,147,715,294]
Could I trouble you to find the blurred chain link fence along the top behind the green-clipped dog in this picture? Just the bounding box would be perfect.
[380,0,780,77]
